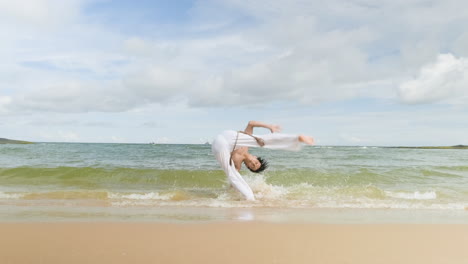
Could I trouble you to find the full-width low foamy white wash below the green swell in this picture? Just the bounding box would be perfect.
[0,175,468,210]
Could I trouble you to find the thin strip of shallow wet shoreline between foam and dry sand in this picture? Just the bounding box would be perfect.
[0,204,468,224]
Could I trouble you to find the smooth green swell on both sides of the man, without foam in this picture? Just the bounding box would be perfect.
[0,164,468,188]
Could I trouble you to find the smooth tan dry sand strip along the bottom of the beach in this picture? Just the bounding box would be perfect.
[0,222,468,264]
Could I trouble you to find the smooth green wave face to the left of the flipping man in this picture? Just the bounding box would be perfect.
[0,167,225,190]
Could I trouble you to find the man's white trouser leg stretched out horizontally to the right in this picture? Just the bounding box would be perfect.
[236,133,301,151]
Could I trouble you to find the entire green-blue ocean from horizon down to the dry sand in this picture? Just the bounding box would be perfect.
[0,143,468,223]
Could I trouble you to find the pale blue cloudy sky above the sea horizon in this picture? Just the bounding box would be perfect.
[0,0,468,146]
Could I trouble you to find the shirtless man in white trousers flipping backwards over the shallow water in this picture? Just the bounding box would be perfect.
[211,121,314,201]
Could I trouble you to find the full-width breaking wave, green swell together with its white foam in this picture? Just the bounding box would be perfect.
[0,165,468,209]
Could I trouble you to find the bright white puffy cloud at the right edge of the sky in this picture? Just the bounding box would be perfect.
[399,54,468,103]
